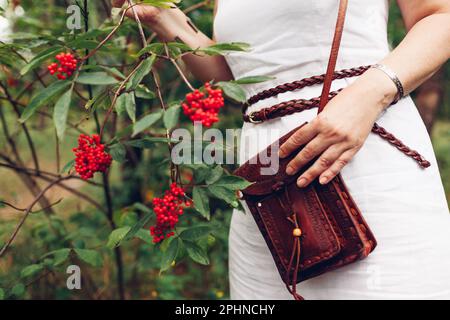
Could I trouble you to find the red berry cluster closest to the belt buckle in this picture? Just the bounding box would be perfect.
[182,83,224,127]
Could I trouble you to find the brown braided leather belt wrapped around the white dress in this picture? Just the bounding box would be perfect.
[242,66,431,168]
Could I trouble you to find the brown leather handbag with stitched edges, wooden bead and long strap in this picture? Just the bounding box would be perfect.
[234,0,429,300]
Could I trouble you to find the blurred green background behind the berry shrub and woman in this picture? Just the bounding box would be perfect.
[0,0,450,299]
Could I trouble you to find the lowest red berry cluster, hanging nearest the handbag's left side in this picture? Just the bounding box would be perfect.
[150,183,192,243]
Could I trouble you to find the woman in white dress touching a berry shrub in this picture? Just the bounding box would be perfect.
[114,0,450,299]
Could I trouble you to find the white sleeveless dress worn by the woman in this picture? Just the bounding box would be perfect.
[215,0,450,299]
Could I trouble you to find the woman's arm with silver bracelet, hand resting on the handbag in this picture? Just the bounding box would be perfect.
[280,0,450,187]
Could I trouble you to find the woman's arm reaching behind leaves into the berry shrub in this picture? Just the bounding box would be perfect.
[112,0,233,82]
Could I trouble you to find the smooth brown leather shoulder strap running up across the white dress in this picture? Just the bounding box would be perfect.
[318,0,348,113]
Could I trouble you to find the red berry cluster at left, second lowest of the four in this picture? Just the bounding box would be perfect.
[72,134,112,180]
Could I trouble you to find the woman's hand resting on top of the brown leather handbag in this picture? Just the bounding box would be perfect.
[279,69,396,187]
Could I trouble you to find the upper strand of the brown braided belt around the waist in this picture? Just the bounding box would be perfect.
[244,66,371,112]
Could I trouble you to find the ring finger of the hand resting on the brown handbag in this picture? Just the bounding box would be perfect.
[297,143,348,187]
